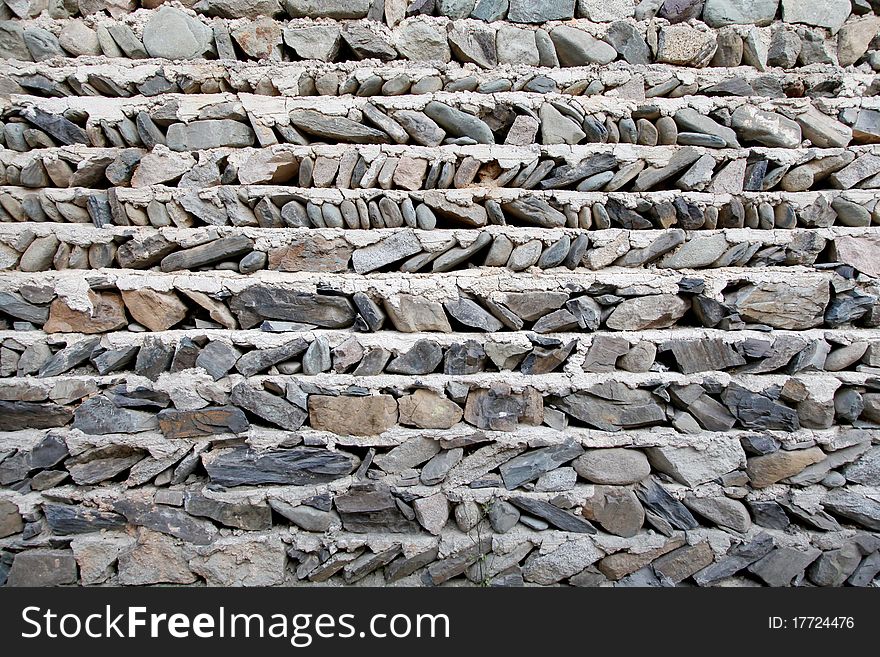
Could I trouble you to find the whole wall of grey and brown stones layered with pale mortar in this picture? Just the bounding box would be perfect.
[0,0,880,586]
